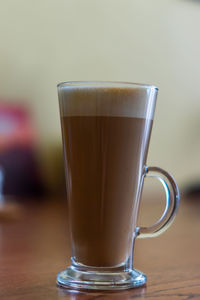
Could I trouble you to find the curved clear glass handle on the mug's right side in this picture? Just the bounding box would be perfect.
[137,167,180,238]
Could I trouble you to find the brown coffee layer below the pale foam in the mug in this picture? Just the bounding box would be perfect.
[62,116,152,267]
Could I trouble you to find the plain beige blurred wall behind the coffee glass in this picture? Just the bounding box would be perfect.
[0,0,200,188]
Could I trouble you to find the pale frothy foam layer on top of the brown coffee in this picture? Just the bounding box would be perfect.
[58,84,157,120]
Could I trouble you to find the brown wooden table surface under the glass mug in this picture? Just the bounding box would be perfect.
[0,199,200,300]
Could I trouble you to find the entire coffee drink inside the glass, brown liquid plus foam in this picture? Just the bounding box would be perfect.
[60,86,154,267]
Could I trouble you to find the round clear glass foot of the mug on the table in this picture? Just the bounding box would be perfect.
[57,266,147,290]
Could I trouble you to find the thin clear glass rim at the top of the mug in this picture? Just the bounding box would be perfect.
[57,80,159,91]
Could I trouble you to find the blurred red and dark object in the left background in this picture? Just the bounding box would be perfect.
[0,104,43,196]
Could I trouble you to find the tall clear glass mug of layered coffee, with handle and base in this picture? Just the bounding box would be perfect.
[57,82,180,290]
